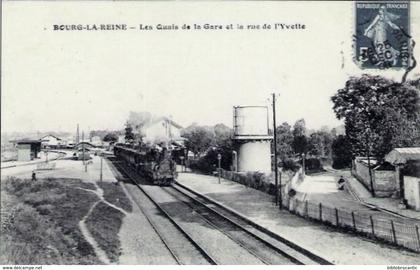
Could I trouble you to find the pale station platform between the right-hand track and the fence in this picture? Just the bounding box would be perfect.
[178,173,420,265]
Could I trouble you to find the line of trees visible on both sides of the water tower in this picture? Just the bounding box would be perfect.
[181,119,342,171]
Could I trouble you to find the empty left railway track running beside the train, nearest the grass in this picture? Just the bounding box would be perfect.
[113,162,217,265]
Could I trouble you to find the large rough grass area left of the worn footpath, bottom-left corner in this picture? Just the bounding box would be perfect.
[0,177,100,264]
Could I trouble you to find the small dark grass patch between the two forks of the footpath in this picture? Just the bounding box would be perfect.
[86,202,124,263]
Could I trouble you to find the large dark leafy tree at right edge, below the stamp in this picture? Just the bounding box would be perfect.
[331,75,420,160]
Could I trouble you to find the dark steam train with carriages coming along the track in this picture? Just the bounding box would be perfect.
[114,145,177,186]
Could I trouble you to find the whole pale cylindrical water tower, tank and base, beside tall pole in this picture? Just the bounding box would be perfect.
[233,106,273,173]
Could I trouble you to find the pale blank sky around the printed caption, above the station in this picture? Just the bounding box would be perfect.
[1,1,420,132]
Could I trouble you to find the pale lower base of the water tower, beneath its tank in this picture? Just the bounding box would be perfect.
[238,140,271,173]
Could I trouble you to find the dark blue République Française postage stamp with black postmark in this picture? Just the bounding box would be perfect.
[355,1,411,69]
